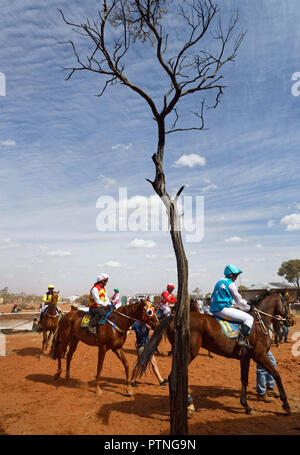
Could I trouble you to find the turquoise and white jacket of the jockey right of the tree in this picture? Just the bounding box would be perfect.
[210,278,250,313]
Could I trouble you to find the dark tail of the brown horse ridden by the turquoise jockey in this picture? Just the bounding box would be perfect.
[134,317,172,378]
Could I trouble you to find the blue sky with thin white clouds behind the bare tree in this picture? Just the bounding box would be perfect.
[0,0,300,296]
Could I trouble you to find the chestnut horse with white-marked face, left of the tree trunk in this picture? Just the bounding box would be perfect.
[50,301,159,396]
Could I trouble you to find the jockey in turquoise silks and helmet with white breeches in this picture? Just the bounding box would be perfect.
[210,265,254,347]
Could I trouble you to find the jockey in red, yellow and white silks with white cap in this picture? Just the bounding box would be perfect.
[88,273,115,335]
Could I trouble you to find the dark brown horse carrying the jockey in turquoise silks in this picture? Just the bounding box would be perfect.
[135,291,295,418]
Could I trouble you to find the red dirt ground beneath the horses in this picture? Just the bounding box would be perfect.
[0,310,300,436]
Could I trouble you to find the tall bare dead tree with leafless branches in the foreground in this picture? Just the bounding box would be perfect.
[59,0,244,435]
